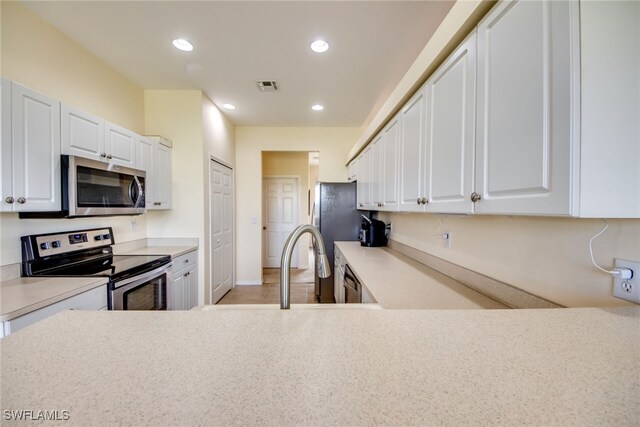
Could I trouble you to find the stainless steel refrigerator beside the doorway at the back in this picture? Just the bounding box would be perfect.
[312,182,361,302]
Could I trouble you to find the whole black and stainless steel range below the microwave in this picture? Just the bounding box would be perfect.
[21,227,172,310]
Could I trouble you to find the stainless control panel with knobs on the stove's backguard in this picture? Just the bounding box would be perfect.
[32,228,114,257]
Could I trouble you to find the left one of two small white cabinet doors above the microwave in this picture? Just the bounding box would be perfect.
[61,104,107,160]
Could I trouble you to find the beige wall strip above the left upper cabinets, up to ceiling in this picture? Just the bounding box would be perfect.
[0,1,144,133]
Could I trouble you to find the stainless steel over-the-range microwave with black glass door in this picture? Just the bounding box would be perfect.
[20,155,146,218]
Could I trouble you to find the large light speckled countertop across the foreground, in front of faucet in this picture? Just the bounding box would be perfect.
[0,307,640,426]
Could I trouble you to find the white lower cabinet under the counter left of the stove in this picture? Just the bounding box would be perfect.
[2,285,107,335]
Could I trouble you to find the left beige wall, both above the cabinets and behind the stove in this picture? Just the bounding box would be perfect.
[0,1,147,265]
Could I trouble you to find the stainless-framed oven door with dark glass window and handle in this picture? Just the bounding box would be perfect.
[109,264,172,311]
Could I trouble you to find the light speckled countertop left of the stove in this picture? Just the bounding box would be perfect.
[0,277,107,322]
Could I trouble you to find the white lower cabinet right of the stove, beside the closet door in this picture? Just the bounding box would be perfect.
[170,251,198,310]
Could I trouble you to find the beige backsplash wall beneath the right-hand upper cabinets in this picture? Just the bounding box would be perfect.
[379,213,640,307]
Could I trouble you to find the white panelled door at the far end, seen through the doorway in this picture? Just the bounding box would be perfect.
[262,178,298,268]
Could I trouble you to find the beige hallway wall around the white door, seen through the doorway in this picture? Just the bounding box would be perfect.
[262,151,309,269]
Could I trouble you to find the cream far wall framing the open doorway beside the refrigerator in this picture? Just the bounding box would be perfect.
[236,127,361,284]
